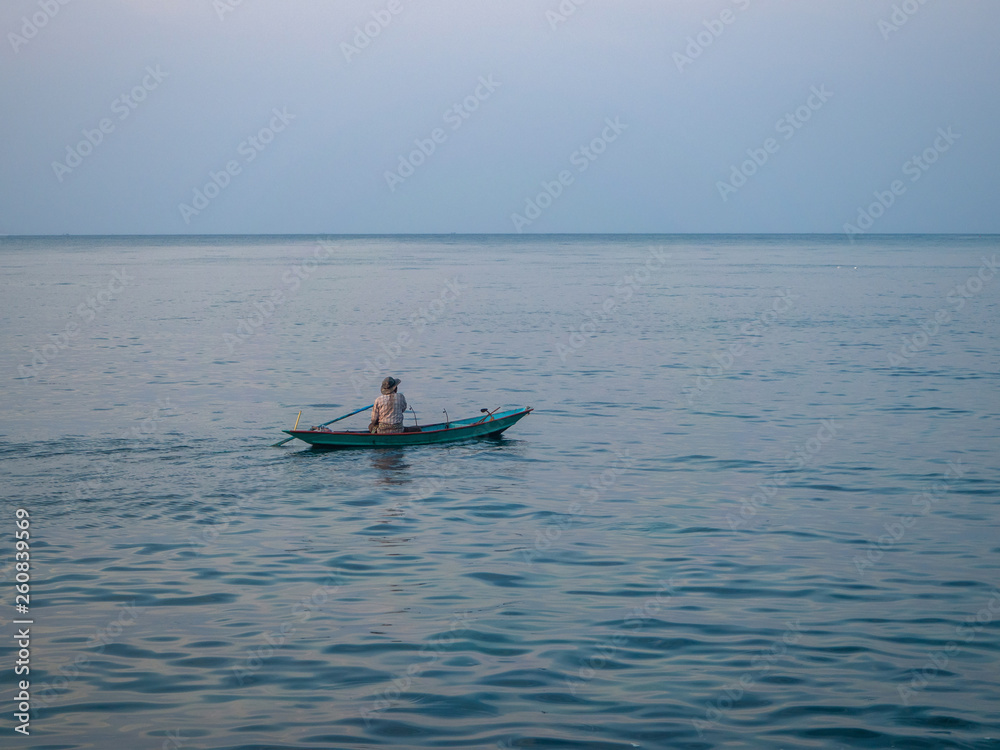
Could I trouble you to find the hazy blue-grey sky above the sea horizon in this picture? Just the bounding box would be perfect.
[0,0,1000,234]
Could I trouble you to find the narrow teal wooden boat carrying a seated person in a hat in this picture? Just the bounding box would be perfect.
[282,406,532,448]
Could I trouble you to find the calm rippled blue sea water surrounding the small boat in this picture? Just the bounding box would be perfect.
[0,236,1000,750]
